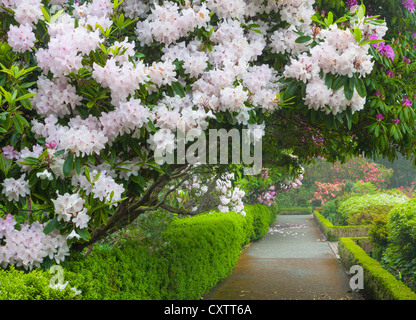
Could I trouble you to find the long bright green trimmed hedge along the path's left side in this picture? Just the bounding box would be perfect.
[0,205,276,300]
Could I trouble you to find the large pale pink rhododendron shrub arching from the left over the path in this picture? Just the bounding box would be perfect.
[0,0,410,267]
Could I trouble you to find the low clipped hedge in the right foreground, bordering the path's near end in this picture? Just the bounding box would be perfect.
[338,238,416,300]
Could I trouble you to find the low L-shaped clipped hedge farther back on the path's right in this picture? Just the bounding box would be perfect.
[313,210,370,241]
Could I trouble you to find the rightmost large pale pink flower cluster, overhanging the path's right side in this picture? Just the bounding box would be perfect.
[284,24,374,114]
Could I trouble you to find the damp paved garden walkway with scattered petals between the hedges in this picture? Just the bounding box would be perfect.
[204,215,359,300]
